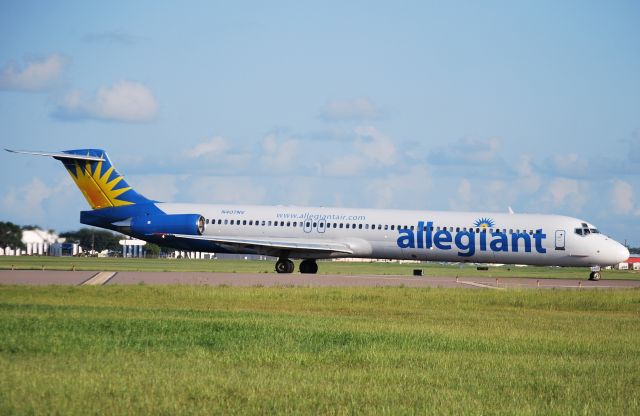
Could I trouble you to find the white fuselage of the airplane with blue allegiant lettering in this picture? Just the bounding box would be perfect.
[157,203,629,266]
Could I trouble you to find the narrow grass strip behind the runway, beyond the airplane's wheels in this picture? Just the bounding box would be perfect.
[0,256,640,280]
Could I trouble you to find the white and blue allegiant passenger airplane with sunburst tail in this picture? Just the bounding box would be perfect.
[5,149,629,280]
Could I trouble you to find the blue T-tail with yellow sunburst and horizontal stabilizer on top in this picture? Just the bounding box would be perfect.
[6,149,152,209]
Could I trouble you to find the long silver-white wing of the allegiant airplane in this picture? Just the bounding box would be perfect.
[171,234,353,255]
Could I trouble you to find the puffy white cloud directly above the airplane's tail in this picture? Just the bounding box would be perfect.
[54,81,158,122]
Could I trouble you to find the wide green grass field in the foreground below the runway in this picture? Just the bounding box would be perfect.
[0,286,640,415]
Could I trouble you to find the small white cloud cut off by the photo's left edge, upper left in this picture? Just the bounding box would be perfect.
[0,54,64,91]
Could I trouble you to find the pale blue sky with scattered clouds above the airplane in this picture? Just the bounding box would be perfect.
[0,1,640,246]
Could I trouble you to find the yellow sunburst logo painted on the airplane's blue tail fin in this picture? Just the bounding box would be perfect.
[67,161,133,209]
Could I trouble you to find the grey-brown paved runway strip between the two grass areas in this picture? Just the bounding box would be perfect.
[0,270,640,290]
